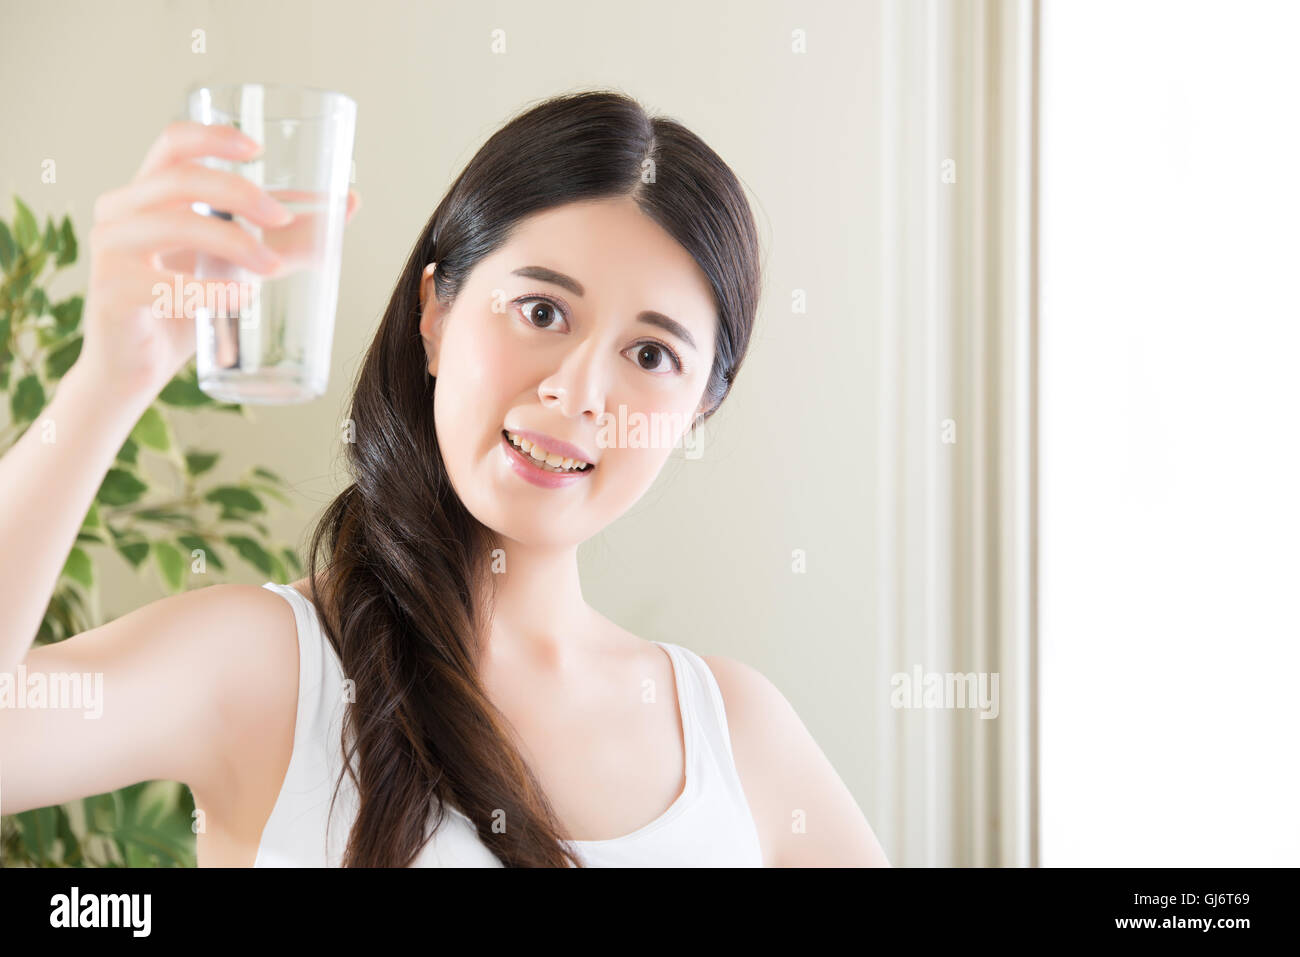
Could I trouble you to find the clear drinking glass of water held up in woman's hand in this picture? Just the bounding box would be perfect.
[186,83,356,404]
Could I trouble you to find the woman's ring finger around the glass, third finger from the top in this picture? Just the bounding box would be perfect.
[90,209,283,274]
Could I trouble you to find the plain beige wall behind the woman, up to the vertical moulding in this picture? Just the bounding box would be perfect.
[0,0,892,852]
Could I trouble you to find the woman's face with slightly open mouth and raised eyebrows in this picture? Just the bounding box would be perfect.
[420,198,716,546]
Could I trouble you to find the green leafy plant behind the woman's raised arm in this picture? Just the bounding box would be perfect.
[0,196,302,867]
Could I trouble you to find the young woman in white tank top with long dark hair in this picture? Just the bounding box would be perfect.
[0,91,888,866]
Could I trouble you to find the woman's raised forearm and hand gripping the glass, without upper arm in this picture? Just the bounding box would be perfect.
[0,122,292,671]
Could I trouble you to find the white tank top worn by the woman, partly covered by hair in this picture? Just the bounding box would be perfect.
[254,581,763,867]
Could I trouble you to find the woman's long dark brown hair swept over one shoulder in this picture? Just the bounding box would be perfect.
[308,90,761,867]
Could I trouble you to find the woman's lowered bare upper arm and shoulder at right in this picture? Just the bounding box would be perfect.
[705,655,891,867]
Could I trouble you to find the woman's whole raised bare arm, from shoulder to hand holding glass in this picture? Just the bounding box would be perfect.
[0,122,296,814]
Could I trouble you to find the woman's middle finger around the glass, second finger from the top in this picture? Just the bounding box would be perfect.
[95,161,293,228]
